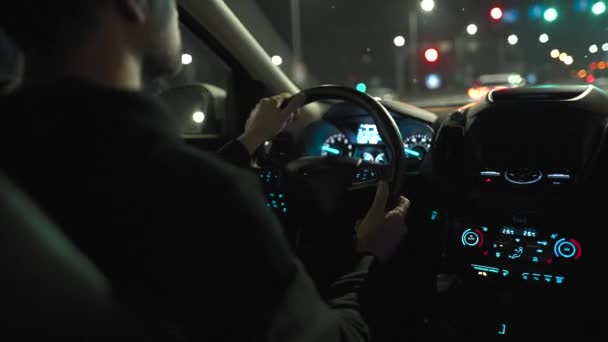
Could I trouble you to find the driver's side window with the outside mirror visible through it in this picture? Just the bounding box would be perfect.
[146,25,232,135]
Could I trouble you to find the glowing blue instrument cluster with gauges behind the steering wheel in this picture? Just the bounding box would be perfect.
[303,104,434,165]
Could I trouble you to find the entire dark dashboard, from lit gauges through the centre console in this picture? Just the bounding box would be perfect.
[255,86,608,340]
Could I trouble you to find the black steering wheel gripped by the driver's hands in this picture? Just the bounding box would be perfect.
[284,86,406,281]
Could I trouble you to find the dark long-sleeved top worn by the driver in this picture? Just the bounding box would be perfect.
[0,80,373,342]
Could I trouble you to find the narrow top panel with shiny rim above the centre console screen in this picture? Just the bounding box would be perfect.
[488,85,593,102]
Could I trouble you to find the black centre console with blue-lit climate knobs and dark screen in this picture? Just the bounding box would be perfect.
[432,88,608,340]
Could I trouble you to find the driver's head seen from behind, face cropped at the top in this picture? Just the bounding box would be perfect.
[0,0,181,87]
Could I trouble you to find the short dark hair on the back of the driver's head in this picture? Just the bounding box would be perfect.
[0,0,102,57]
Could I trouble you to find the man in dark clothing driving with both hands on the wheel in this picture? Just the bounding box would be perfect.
[0,0,408,341]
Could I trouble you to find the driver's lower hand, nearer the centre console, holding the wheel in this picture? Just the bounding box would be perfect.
[356,182,410,263]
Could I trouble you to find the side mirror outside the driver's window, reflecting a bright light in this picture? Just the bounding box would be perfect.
[158,83,226,134]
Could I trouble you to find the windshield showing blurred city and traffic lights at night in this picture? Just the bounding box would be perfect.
[226,0,608,106]
